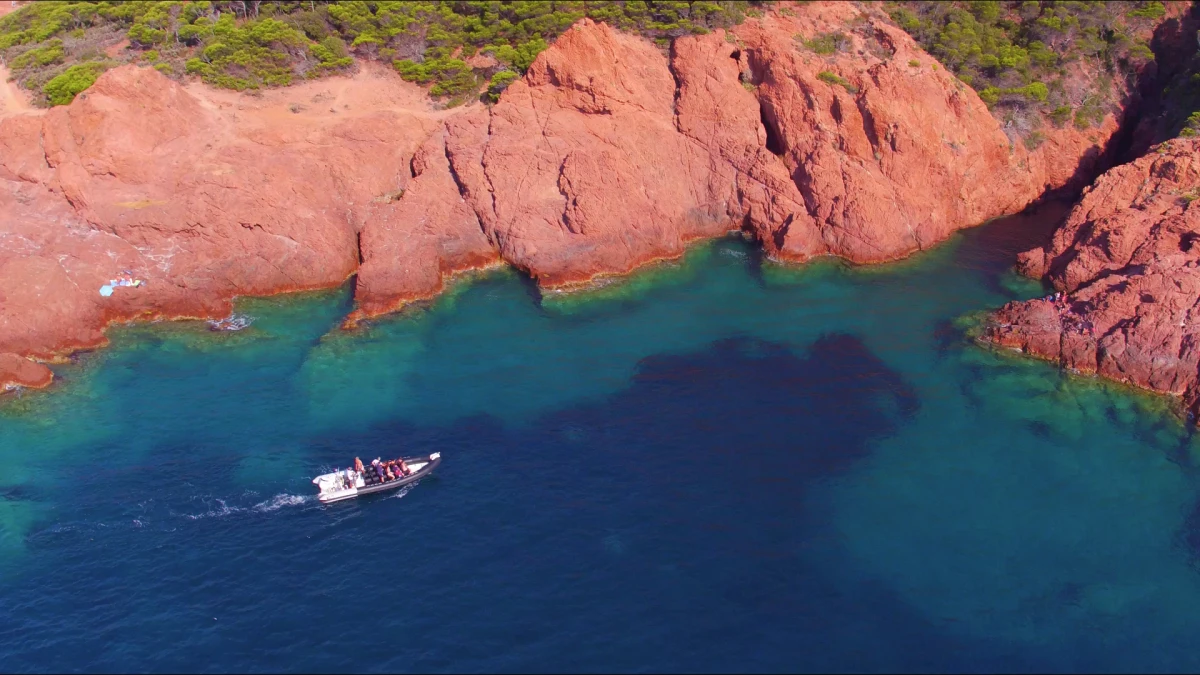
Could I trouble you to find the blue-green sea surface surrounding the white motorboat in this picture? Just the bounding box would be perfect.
[0,207,1200,673]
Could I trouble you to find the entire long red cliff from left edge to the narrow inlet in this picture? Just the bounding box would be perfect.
[0,2,1116,381]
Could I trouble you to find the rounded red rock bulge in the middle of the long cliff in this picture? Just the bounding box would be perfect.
[449,20,737,286]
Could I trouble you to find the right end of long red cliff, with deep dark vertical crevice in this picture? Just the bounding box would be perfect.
[720,4,1116,262]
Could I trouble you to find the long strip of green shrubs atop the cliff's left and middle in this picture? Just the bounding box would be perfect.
[0,0,758,104]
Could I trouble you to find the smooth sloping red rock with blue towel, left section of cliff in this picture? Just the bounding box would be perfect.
[0,61,439,359]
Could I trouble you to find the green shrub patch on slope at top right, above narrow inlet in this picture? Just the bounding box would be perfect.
[887,0,1165,129]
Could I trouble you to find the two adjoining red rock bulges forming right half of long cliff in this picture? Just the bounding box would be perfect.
[448,4,1116,286]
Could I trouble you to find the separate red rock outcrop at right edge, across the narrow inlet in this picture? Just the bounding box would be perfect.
[986,138,1200,406]
